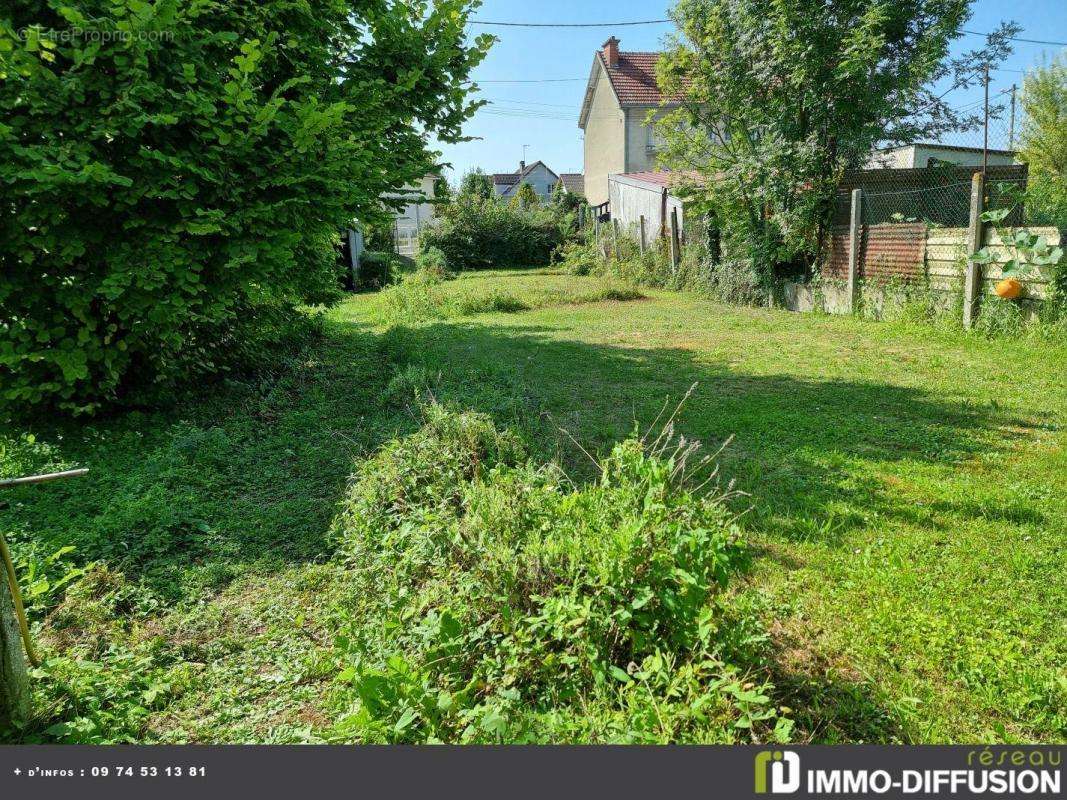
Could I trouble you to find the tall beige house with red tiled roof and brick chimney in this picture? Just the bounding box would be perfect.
[578,36,680,206]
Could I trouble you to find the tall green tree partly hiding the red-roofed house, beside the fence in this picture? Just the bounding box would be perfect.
[658,0,1018,282]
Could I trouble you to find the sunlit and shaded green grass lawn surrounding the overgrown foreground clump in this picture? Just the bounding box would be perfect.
[0,272,1067,742]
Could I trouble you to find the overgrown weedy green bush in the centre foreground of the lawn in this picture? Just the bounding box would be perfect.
[332,404,775,741]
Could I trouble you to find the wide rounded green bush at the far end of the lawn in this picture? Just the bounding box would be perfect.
[420,195,562,270]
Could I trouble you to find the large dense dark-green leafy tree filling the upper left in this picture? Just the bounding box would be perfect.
[0,0,491,412]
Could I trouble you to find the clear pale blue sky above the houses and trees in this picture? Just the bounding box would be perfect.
[441,0,1067,179]
